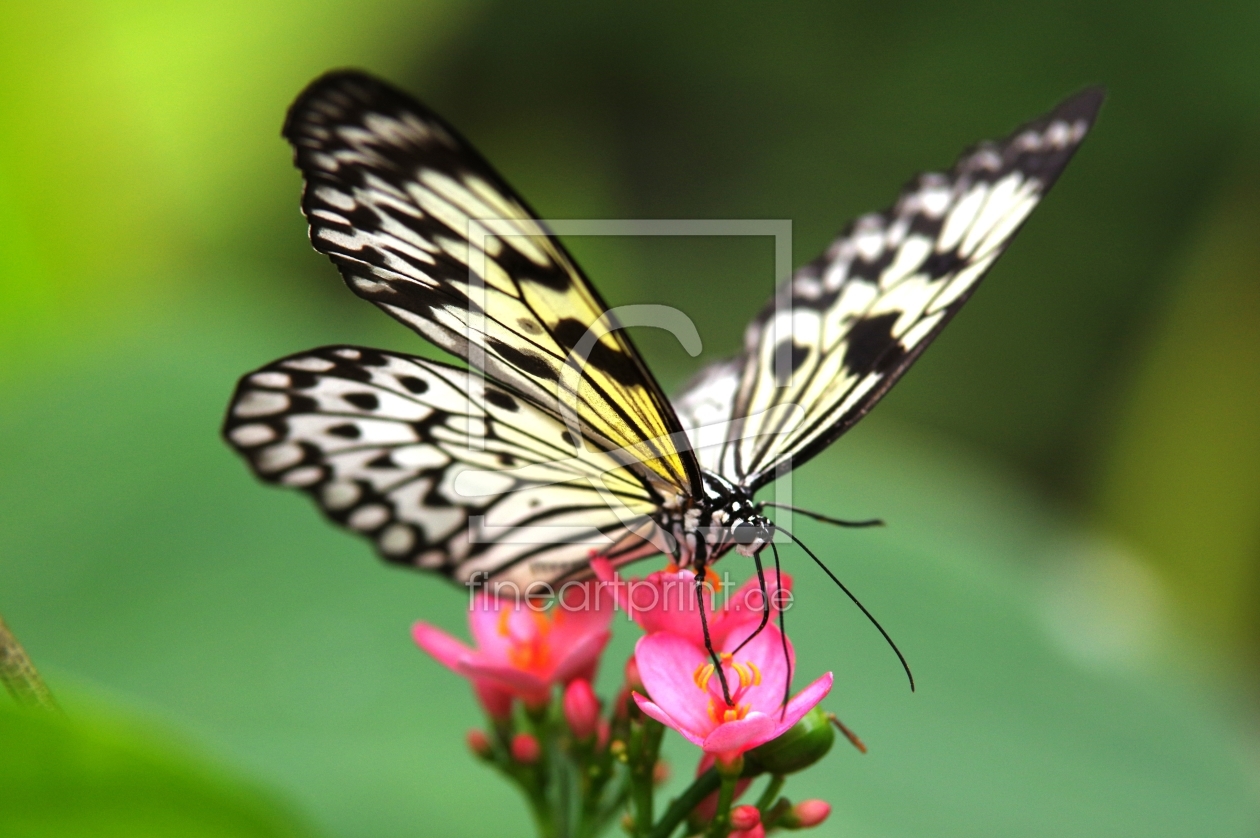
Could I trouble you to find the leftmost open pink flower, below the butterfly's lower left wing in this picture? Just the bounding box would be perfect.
[412,582,612,718]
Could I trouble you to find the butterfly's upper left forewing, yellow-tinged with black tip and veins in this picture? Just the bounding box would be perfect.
[284,72,699,494]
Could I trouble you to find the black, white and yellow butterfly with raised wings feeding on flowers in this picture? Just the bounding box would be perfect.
[223,71,1103,690]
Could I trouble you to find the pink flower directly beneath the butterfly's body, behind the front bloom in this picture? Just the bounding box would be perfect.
[591,558,791,648]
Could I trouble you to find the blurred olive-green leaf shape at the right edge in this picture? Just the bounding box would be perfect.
[1095,161,1260,670]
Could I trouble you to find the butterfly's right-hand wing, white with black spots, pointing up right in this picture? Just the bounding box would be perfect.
[678,89,1103,489]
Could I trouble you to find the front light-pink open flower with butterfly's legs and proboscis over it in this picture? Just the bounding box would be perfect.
[634,625,832,762]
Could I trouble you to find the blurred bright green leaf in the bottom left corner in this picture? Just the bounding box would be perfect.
[0,704,314,838]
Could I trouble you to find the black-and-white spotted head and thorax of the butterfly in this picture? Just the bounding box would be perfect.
[659,469,772,567]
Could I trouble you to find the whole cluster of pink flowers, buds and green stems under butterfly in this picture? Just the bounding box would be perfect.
[413,558,861,838]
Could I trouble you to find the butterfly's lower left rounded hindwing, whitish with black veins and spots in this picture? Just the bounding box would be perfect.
[223,347,662,590]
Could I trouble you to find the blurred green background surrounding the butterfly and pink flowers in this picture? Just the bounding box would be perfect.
[0,0,1260,838]
